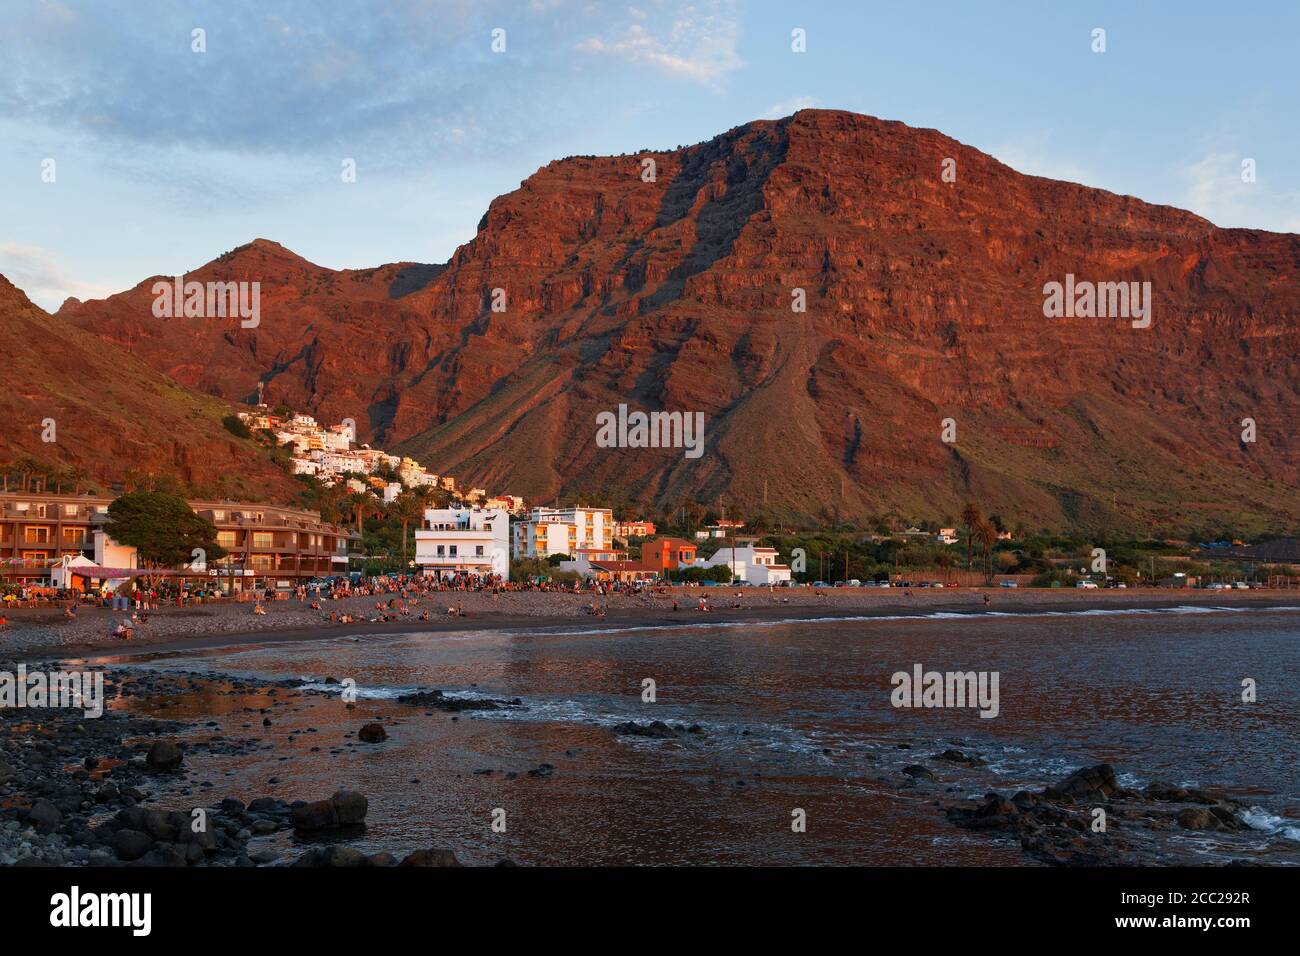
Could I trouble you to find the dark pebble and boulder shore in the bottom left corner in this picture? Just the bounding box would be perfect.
[0,662,488,866]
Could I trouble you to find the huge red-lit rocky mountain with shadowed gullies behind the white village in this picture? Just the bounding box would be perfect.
[48,111,1300,531]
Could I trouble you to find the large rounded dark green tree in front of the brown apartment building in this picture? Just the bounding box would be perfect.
[104,492,226,580]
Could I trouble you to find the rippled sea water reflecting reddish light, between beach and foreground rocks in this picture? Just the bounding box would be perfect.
[83,607,1300,865]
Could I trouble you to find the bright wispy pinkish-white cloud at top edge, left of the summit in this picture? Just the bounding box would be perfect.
[577,3,745,90]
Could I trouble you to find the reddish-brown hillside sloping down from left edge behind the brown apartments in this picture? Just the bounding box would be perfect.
[0,276,300,501]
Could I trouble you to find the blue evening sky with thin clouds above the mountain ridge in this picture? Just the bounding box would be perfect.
[0,0,1300,310]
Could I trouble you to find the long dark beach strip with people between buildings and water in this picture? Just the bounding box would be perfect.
[0,588,1300,659]
